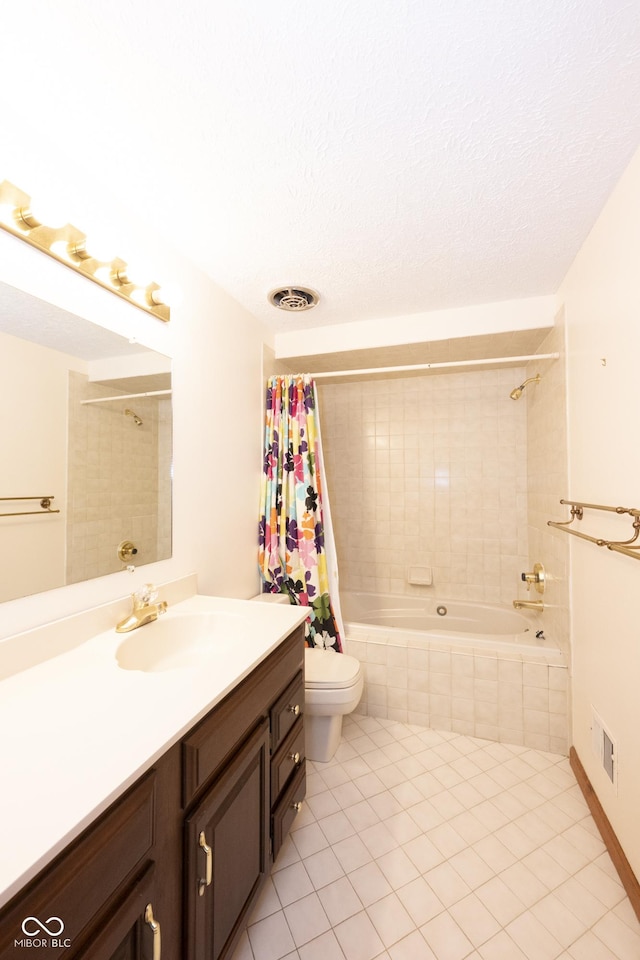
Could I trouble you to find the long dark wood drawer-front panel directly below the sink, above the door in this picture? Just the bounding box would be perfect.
[183,626,304,807]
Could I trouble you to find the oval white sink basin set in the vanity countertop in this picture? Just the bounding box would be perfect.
[116,610,247,673]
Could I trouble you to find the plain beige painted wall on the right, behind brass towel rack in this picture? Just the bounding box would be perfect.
[558,144,640,876]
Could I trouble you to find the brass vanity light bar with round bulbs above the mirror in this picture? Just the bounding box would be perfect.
[0,180,171,323]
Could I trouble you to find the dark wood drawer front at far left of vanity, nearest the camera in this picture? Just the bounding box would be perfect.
[0,771,155,958]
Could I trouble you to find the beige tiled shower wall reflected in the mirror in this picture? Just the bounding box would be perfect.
[66,372,171,583]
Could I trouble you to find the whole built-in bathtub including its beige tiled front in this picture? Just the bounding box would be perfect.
[340,591,569,756]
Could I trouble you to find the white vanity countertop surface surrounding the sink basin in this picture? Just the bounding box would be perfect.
[0,593,308,907]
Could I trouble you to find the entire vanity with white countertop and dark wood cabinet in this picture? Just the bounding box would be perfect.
[0,584,305,960]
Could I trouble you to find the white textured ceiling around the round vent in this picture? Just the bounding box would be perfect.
[0,0,640,333]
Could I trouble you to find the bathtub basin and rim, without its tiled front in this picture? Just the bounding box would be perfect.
[340,591,563,663]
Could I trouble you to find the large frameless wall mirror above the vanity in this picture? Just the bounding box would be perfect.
[0,283,172,602]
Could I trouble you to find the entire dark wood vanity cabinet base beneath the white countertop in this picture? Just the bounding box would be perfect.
[0,627,305,960]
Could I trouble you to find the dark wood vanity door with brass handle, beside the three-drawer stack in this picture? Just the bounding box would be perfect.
[185,720,269,960]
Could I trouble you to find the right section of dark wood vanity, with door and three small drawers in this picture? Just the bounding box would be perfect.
[183,627,305,960]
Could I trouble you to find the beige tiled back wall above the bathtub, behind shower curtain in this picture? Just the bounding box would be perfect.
[319,368,528,603]
